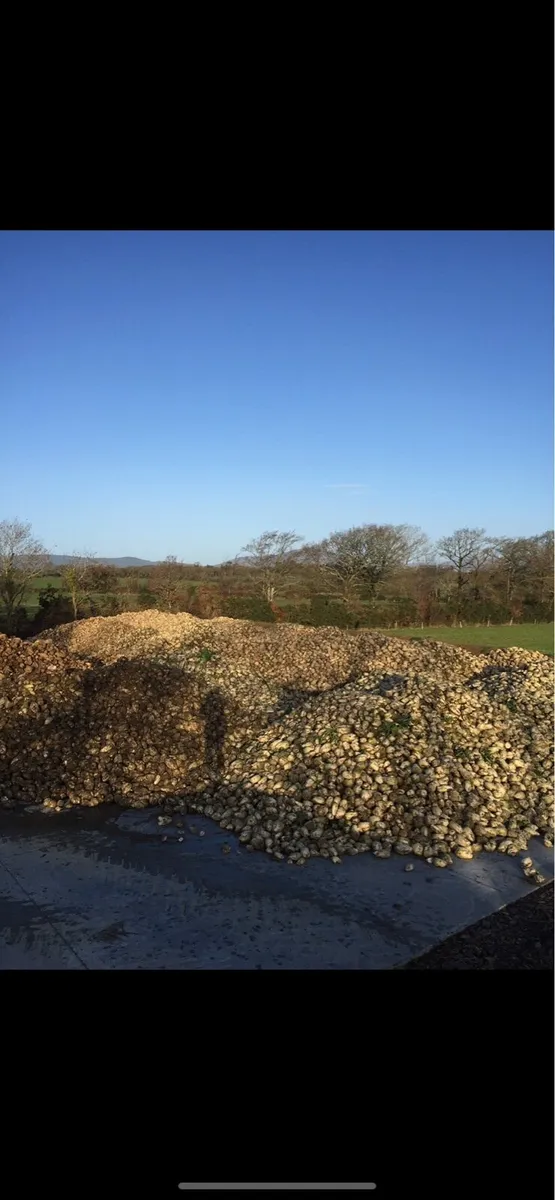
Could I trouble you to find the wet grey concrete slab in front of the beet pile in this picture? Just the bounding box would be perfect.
[0,805,554,971]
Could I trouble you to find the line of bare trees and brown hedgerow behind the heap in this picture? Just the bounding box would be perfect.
[0,520,554,636]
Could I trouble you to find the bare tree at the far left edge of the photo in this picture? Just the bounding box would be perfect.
[0,518,50,632]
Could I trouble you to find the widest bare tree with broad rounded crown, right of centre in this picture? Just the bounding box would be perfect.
[312,524,426,604]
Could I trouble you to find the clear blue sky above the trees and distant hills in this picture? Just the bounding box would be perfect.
[0,230,554,563]
